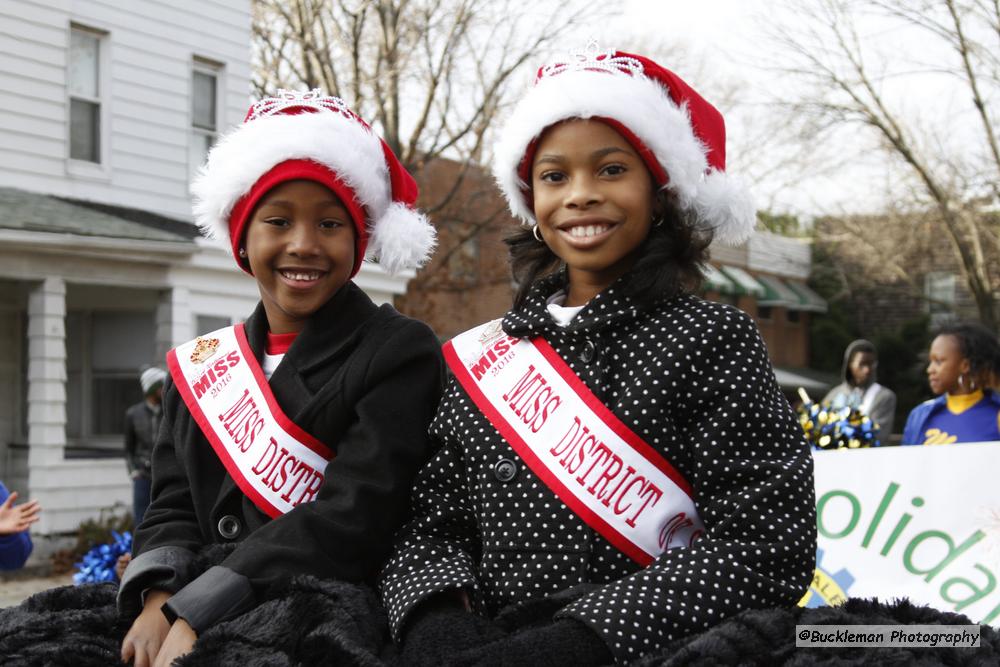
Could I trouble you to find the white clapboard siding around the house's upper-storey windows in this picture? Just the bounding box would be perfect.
[0,0,250,219]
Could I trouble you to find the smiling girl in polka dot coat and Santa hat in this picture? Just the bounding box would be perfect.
[380,48,815,665]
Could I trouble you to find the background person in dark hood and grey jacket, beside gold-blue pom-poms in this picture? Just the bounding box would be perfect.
[823,339,896,442]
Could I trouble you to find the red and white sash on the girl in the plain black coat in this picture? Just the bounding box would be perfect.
[167,324,333,518]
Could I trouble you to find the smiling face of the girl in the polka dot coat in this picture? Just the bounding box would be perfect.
[531,119,654,306]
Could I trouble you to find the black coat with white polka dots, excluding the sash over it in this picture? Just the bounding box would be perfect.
[381,280,816,662]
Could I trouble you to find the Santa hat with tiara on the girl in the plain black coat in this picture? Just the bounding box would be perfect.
[191,90,435,276]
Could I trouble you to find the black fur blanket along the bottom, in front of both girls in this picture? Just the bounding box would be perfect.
[0,578,1000,667]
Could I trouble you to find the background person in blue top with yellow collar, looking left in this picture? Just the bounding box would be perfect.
[902,323,1000,445]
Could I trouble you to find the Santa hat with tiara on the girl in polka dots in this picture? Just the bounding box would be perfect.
[493,43,756,245]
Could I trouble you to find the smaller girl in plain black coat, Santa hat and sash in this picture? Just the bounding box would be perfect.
[118,91,443,667]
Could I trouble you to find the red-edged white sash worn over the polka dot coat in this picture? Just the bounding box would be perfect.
[444,320,704,565]
